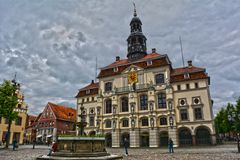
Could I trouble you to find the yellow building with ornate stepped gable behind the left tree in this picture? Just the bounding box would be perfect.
[0,80,28,144]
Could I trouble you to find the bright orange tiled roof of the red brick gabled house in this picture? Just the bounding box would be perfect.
[48,102,76,121]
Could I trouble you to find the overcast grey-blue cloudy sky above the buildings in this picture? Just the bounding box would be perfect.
[0,0,240,115]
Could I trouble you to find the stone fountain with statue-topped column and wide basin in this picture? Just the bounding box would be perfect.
[37,104,123,160]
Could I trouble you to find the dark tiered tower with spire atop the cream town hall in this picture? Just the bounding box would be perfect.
[127,5,147,61]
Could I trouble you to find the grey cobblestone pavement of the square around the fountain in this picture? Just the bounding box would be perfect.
[0,145,240,160]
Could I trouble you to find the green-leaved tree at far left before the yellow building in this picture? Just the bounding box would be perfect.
[0,80,18,148]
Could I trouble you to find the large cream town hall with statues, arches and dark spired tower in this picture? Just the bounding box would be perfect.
[76,10,216,147]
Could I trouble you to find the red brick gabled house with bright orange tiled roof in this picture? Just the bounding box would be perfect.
[34,102,76,143]
